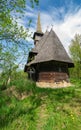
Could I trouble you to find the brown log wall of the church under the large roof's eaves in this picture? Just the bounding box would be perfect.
[38,62,69,82]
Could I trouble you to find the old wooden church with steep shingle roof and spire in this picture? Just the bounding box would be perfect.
[24,14,74,83]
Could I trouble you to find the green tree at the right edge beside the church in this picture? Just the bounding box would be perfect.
[69,34,81,78]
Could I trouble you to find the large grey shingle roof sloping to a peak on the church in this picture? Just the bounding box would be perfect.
[28,29,73,66]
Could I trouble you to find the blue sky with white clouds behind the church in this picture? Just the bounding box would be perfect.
[14,0,81,68]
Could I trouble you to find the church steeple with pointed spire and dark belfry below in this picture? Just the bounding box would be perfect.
[33,12,43,44]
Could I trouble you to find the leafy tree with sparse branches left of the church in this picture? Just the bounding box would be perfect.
[0,0,38,87]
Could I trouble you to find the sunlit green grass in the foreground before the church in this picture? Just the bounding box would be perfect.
[0,79,81,130]
